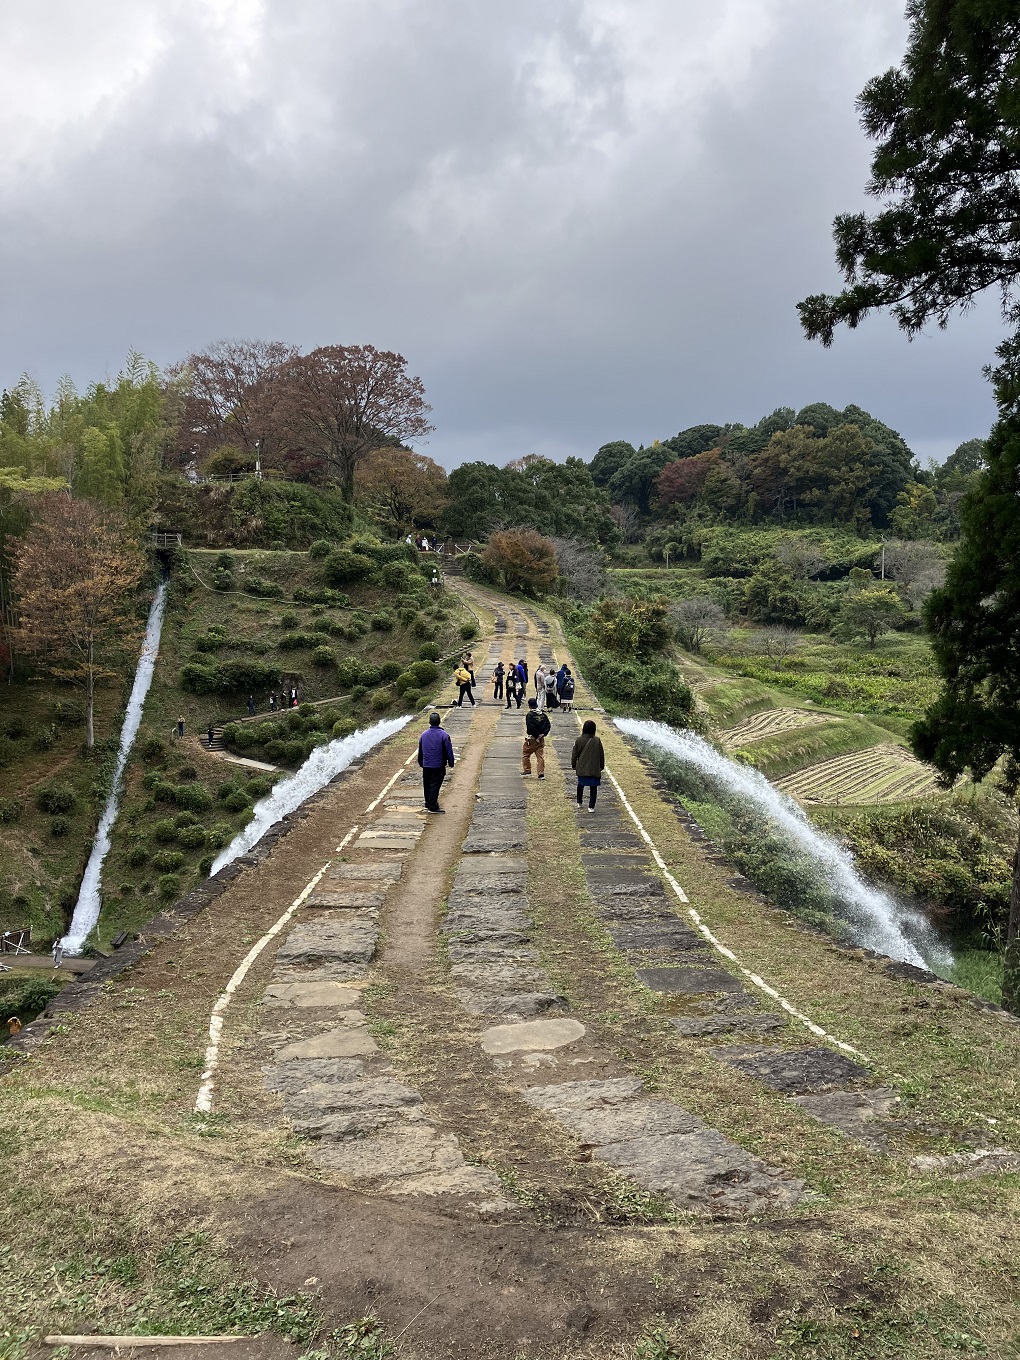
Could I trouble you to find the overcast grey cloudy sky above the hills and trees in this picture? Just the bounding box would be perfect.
[0,0,1001,466]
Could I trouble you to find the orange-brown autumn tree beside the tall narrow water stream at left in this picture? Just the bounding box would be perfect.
[14,495,143,747]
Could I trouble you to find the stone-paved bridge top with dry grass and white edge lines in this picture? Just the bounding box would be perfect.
[0,586,1020,1360]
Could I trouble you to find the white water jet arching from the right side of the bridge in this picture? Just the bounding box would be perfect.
[613,718,952,971]
